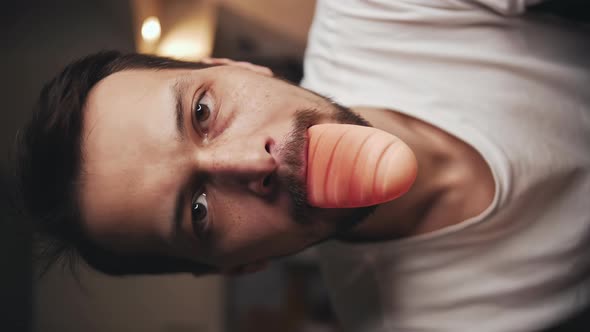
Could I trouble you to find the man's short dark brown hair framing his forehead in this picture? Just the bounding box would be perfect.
[16,51,219,276]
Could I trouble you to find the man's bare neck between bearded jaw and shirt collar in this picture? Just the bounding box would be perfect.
[341,108,460,241]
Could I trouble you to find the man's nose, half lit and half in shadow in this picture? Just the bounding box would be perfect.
[199,138,279,196]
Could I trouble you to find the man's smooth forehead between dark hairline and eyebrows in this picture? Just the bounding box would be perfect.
[80,70,190,252]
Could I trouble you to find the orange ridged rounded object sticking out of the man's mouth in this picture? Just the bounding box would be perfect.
[307,124,417,208]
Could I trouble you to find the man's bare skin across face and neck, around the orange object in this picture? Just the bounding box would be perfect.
[79,60,494,272]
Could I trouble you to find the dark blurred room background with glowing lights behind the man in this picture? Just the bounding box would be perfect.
[0,0,337,332]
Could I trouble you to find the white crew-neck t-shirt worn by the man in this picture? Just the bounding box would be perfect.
[302,0,590,332]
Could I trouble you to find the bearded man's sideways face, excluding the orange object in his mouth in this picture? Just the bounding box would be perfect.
[80,66,368,268]
